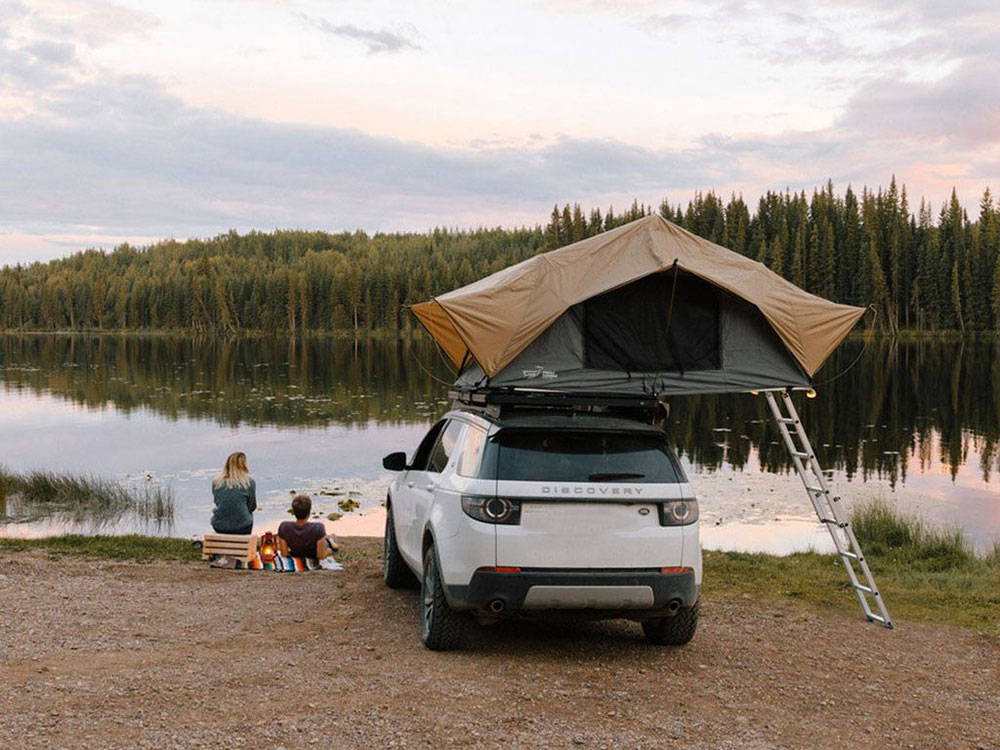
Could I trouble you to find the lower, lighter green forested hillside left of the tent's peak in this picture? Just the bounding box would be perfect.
[0,228,542,333]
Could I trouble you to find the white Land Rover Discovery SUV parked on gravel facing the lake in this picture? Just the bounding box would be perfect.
[382,409,701,650]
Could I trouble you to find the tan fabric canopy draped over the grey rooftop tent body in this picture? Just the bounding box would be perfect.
[411,216,864,388]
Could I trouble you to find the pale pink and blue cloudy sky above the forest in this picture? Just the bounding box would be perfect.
[0,0,1000,264]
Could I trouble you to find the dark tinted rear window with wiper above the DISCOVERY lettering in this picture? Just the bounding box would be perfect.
[481,430,684,483]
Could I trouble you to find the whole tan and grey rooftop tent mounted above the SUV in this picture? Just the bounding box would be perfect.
[411,216,865,397]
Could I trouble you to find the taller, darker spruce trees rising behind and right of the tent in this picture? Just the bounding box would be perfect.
[545,179,1000,332]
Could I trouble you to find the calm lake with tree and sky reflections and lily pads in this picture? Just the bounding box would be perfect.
[0,336,1000,552]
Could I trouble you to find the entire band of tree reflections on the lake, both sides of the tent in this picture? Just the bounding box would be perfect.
[0,335,1000,485]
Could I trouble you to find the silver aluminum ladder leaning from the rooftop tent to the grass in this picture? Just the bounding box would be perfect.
[764,390,892,628]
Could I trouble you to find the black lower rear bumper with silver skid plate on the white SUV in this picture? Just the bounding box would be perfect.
[445,568,698,619]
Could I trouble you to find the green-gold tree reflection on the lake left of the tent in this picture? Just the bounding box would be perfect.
[0,335,449,427]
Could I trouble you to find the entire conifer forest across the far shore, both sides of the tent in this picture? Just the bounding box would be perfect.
[0,179,1000,333]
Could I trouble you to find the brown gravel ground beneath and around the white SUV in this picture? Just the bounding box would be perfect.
[0,539,1000,750]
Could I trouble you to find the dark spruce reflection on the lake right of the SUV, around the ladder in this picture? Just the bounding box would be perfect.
[671,340,1000,487]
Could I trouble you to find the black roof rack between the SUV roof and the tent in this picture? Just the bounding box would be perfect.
[448,388,666,420]
